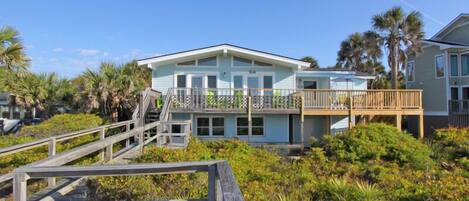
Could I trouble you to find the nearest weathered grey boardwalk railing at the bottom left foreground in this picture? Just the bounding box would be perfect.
[14,161,243,201]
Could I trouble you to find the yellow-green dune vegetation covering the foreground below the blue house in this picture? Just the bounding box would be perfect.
[90,124,469,201]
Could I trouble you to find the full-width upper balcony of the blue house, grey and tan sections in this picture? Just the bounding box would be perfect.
[167,88,423,115]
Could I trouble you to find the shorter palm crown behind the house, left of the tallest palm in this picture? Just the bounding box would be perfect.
[337,31,382,74]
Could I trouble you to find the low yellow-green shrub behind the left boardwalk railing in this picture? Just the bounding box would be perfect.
[20,114,103,138]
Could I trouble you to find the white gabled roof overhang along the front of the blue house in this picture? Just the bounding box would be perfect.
[137,44,310,69]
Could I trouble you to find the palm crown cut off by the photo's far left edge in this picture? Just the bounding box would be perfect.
[0,26,29,72]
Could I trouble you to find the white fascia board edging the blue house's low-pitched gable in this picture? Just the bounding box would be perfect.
[137,45,310,69]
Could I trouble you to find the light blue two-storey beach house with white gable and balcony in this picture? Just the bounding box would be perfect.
[138,44,423,145]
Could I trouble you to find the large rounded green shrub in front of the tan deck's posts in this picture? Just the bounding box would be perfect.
[324,123,433,169]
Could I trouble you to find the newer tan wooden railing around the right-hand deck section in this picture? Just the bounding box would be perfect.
[303,89,422,110]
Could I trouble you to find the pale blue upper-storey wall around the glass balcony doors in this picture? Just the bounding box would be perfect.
[152,55,295,94]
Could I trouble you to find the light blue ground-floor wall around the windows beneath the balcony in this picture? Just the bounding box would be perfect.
[172,113,289,144]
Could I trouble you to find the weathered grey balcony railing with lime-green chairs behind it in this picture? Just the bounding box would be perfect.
[170,88,301,111]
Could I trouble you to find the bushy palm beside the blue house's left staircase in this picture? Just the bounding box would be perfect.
[77,62,151,121]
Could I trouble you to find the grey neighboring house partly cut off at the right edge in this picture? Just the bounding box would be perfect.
[406,14,469,132]
